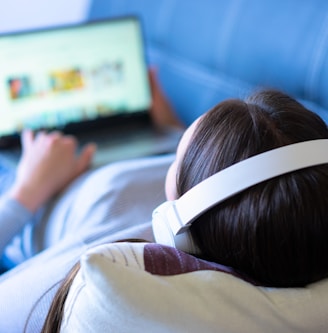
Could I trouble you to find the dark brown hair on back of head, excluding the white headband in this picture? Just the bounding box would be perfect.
[177,91,328,287]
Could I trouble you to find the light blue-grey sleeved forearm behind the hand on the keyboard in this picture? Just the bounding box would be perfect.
[0,196,32,256]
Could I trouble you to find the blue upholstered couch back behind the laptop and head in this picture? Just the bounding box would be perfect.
[89,0,328,124]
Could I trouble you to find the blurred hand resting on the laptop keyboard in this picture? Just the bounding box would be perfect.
[9,131,96,212]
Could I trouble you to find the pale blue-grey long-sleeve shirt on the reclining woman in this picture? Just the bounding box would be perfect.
[0,156,173,333]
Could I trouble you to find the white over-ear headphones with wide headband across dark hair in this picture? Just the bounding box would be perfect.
[152,139,328,254]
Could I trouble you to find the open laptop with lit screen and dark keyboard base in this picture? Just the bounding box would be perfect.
[0,16,181,166]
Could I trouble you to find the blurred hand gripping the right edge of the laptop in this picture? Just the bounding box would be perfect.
[149,68,183,128]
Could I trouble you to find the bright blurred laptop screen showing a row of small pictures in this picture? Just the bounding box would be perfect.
[0,17,151,144]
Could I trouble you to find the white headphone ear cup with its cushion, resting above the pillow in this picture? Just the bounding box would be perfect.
[152,201,200,254]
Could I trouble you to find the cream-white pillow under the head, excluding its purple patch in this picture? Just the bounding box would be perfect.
[61,243,328,333]
